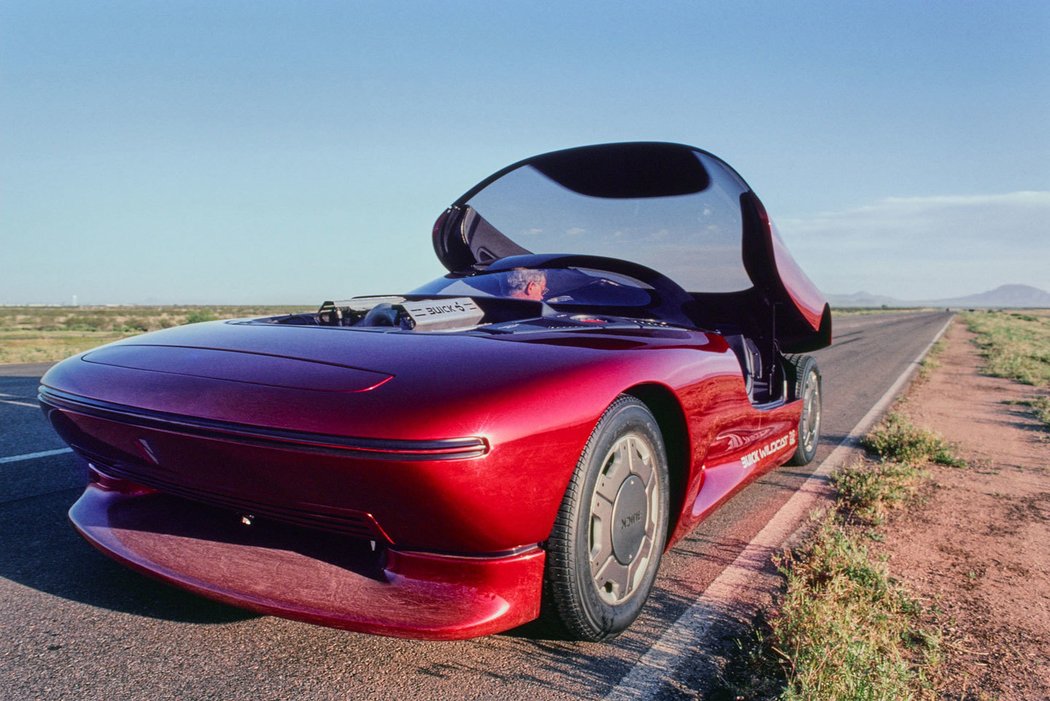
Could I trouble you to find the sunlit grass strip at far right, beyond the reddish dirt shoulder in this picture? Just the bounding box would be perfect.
[963,311,1050,387]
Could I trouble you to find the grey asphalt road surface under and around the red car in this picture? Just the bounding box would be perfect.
[0,313,947,701]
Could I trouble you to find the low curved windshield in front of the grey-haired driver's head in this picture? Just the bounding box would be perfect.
[408,268,653,306]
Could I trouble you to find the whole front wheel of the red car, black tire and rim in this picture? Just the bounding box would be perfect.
[544,395,670,640]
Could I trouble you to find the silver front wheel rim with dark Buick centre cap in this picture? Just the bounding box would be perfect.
[588,432,660,604]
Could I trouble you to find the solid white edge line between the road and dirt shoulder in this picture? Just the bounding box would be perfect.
[605,315,954,701]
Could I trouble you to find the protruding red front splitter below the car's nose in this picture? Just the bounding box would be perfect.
[69,484,545,639]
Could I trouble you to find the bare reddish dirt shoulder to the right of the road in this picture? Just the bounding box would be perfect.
[883,321,1050,700]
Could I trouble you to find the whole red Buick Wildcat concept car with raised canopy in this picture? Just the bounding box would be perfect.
[40,143,831,640]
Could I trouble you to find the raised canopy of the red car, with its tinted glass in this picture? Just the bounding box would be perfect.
[434,143,831,349]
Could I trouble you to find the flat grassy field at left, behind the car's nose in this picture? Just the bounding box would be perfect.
[0,306,302,363]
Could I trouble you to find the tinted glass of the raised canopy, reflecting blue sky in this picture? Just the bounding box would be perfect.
[463,150,752,292]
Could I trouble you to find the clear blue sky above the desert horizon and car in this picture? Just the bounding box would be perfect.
[0,0,1050,305]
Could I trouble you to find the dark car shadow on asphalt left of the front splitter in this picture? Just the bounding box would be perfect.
[0,489,258,623]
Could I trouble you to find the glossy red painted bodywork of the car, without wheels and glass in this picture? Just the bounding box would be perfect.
[40,142,831,638]
